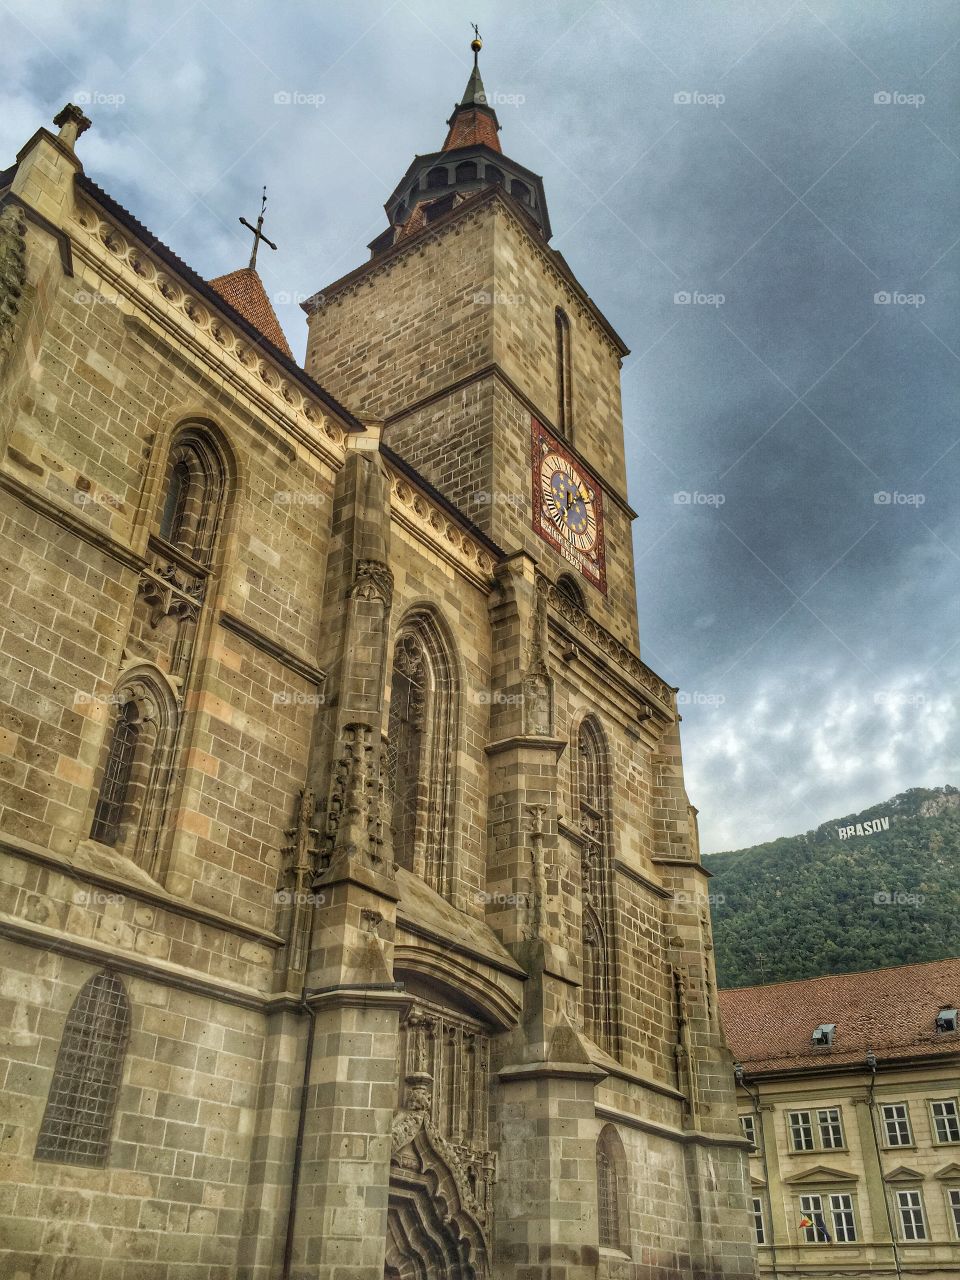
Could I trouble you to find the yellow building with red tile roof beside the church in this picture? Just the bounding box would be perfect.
[721,960,960,1276]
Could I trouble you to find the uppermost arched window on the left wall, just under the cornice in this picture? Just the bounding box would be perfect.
[159,428,224,564]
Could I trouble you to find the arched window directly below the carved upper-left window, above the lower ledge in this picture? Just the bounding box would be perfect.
[90,668,177,872]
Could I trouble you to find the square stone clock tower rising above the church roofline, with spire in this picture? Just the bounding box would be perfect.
[305,41,639,648]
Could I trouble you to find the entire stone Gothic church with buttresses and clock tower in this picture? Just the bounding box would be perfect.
[0,40,755,1280]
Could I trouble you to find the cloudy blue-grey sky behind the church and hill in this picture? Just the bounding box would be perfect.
[0,0,960,851]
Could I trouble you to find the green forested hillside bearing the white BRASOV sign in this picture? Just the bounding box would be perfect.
[704,786,960,987]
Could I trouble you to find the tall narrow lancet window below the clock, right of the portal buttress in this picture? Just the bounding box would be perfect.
[577,717,617,1052]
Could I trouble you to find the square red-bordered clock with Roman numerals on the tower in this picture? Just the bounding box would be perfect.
[531,419,607,591]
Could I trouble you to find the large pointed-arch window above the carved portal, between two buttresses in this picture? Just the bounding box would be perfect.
[387,612,457,895]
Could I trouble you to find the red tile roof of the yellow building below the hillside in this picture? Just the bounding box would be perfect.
[719,959,960,1074]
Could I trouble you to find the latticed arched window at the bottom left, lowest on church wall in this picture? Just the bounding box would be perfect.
[35,973,131,1165]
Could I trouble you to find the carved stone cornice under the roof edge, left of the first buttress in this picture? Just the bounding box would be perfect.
[72,189,362,466]
